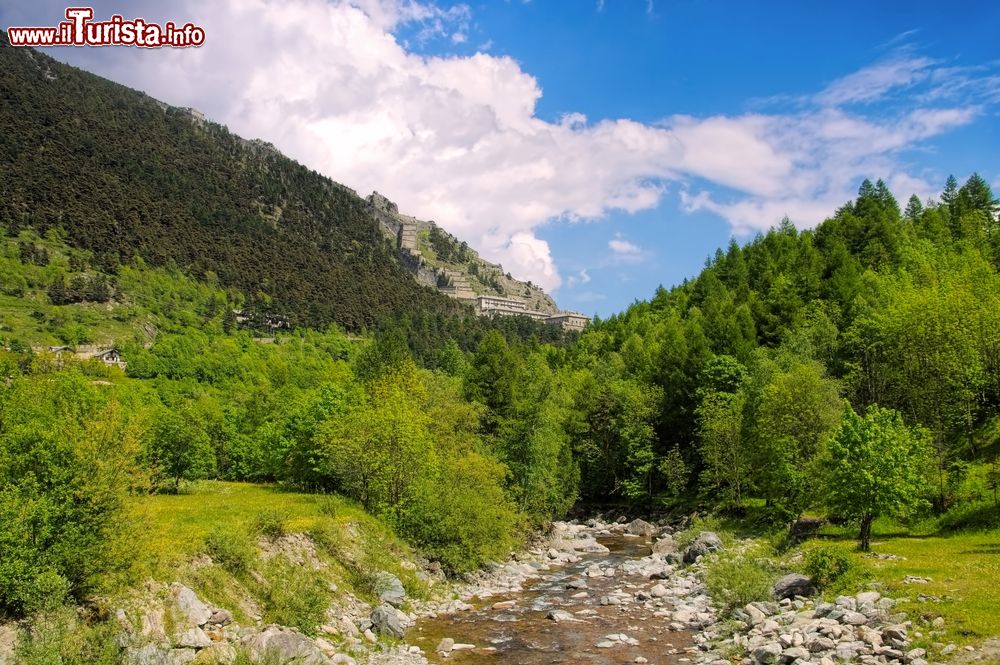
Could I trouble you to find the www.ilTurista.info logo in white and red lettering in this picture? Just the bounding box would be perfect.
[7,7,205,48]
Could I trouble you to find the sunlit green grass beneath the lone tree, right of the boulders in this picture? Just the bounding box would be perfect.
[807,521,1000,646]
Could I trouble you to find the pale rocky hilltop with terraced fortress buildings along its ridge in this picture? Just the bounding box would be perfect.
[365,192,590,330]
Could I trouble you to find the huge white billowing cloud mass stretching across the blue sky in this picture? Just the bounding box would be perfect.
[0,0,1000,289]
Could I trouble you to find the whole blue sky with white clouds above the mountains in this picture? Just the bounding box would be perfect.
[0,0,1000,315]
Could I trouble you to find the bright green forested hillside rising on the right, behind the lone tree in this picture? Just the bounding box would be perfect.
[572,175,1000,519]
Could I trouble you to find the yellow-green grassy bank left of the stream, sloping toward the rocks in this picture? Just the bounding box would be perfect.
[135,481,427,614]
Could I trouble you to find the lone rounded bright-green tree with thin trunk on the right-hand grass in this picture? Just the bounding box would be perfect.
[826,405,929,552]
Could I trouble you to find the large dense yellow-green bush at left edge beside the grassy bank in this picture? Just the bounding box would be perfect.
[0,371,139,617]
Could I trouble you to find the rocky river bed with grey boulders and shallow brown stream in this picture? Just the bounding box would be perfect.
[43,519,952,665]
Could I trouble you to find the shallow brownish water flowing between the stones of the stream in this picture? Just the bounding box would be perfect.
[406,536,691,665]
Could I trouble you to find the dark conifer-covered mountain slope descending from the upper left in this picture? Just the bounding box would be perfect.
[0,33,461,330]
